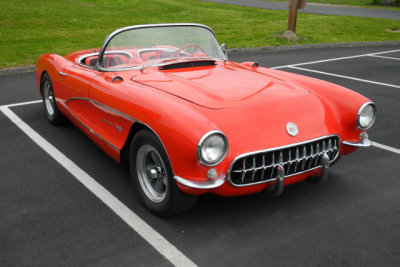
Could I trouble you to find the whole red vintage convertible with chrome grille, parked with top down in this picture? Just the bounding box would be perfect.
[36,24,376,216]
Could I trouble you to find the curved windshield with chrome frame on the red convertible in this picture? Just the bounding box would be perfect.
[100,25,225,70]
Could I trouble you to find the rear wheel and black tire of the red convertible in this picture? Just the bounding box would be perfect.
[40,72,64,125]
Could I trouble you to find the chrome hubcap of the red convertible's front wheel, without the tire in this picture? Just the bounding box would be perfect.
[136,145,168,203]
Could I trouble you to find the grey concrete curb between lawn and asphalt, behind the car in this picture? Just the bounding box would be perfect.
[0,41,400,76]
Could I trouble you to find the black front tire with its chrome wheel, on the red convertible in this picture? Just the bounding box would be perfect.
[129,129,198,217]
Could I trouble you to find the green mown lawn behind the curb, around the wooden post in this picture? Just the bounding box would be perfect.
[0,0,400,68]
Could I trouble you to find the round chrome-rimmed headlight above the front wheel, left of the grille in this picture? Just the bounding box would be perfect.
[197,131,228,166]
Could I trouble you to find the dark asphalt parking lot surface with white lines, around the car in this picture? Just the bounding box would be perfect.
[0,46,400,266]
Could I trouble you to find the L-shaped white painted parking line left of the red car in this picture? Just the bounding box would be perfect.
[0,101,196,266]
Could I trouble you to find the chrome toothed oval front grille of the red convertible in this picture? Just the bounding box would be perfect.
[228,135,340,186]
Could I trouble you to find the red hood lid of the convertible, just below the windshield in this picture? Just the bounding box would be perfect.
[132,62,310,109]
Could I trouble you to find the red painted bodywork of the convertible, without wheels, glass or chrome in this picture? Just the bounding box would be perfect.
[36,47,369,196]
